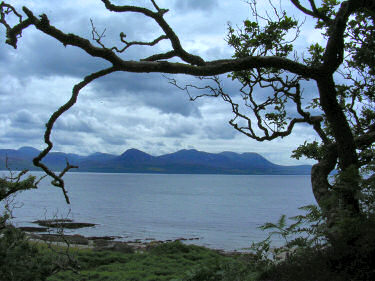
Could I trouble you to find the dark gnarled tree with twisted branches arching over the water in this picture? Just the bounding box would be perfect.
[0,0,375,228]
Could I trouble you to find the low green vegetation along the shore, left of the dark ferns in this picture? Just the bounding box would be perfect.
[0,221,260,281]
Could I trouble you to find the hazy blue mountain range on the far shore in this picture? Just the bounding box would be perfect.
[0,147,311,175]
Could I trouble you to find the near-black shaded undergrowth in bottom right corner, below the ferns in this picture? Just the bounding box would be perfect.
[261,217,375,281]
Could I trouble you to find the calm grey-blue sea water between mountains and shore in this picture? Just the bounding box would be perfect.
[3,173,315,250]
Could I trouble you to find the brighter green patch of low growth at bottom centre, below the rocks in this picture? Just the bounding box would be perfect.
[47,242,253,281]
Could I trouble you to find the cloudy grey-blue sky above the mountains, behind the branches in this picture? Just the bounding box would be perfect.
[0,0,322,165]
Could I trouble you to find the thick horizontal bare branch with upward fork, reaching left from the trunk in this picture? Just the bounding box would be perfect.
[0,4,322,78]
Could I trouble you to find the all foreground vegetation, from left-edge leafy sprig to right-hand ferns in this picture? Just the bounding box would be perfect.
[0,170,375,281]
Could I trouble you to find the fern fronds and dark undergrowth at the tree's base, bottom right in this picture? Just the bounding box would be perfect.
[250,202,375,281]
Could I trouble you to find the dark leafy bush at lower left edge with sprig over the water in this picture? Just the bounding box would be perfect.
[0,169,76,281]
